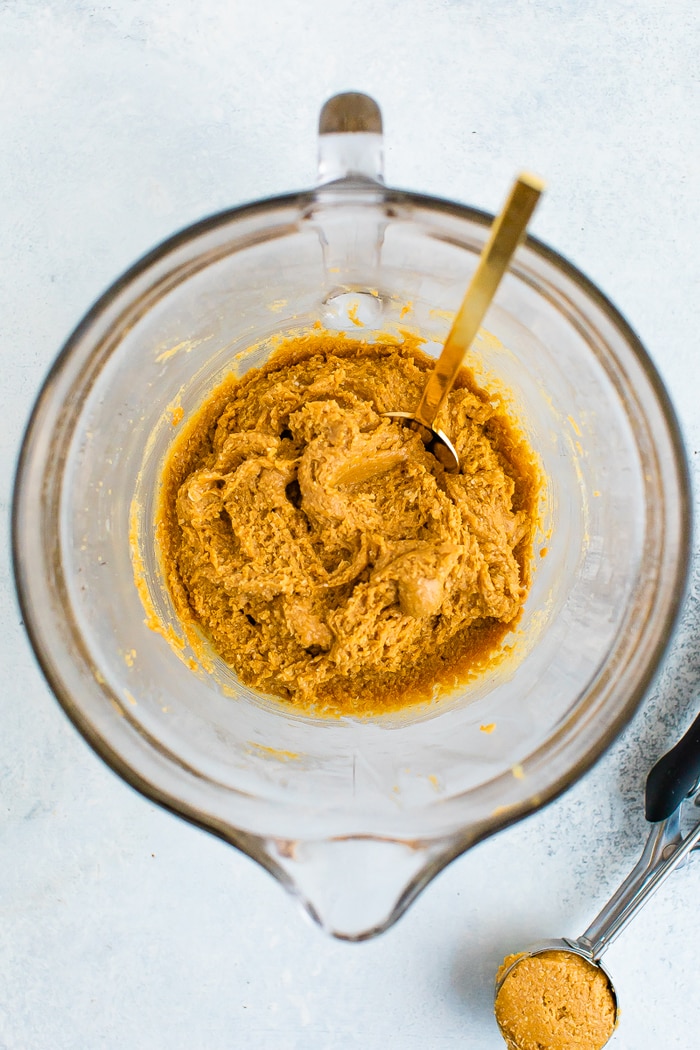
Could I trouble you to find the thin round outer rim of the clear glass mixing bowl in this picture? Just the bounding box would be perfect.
[12,180,692,877]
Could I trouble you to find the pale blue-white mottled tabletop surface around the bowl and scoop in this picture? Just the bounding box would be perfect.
[0,0,700,1050]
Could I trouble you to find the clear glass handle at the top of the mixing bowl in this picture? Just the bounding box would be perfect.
[317,91,384,186]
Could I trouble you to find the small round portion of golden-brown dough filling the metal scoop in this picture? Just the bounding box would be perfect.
[495,951,616,1050]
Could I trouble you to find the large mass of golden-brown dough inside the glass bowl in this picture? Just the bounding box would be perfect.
[157,332,539,714]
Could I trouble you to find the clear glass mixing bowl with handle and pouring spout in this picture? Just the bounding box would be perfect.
[14,96,690,939]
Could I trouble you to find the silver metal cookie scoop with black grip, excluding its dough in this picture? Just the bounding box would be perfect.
[495,715,700,1045]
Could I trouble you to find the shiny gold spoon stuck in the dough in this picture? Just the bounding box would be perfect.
[384,174,545,471]
